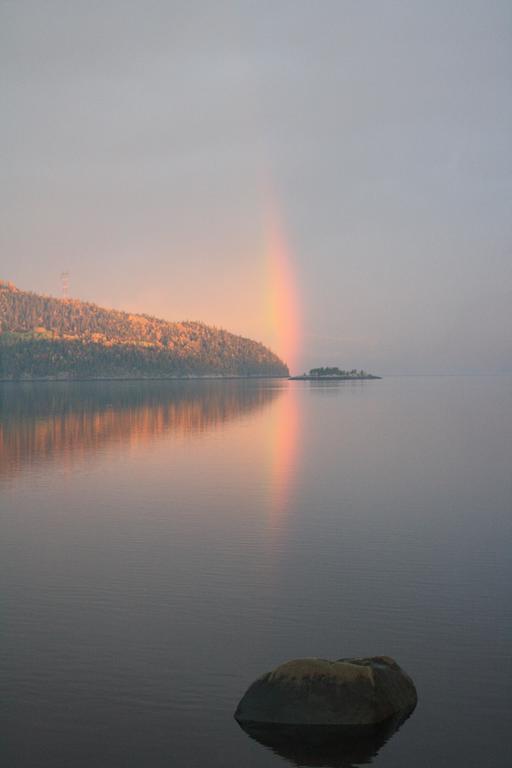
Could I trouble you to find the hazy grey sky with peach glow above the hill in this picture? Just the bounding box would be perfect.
[0,0,512,373]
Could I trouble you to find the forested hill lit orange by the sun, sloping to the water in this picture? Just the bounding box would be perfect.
[0,281,288,380]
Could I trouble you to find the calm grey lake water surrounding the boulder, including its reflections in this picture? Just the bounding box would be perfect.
[0,376,512,768]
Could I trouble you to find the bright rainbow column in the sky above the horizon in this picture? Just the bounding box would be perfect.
[265,206,301,373]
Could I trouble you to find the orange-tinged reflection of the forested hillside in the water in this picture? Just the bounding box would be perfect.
[0,380,279,477]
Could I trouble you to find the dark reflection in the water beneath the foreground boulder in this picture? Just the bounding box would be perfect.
[239,717,407,768]
